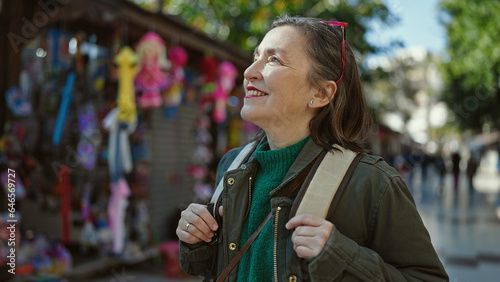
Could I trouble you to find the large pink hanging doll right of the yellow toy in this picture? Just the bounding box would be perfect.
[135,32,168,109]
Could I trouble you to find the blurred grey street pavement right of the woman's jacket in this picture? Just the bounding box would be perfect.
[406,163,500,282]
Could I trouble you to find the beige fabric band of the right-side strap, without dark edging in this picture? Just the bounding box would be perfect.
[296,145,357,218]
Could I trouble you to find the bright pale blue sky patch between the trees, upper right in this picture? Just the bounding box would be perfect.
[366,0,446,64]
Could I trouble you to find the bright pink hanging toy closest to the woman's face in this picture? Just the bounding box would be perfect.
[212,61,238,123]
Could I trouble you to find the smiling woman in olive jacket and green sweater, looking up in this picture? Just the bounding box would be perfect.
[176,17,448,281]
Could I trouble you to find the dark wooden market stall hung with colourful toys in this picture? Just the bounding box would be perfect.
[0,0,255,277]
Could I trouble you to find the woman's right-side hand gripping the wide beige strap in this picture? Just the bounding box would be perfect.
[285,214,333,258]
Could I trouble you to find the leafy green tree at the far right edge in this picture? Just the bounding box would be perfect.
[440,0,500,131]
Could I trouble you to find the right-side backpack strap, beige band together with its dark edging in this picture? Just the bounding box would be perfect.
[290,145,363,218]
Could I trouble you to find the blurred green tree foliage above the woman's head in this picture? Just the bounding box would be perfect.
[163,0,398,57]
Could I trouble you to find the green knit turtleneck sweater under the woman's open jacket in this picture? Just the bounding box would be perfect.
[238,137,309,282]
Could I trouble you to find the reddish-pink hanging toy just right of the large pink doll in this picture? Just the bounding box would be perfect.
[164,46,188,119]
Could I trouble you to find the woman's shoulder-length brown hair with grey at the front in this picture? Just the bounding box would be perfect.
[256,16,366,152]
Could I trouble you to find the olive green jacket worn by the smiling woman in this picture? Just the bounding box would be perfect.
[180,139,449,282]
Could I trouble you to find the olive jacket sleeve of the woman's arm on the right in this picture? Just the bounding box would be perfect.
[308,177,449,281]
